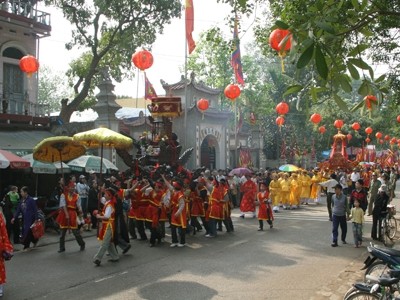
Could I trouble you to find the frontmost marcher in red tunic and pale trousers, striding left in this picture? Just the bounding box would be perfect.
[93,188,119,266]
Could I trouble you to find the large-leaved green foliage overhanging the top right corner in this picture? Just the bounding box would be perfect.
[255,0,400,116]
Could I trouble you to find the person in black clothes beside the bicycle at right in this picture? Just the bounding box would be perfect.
[371,184,389,240]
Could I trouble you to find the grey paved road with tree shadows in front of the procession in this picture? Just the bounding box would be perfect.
[3,196,396,300]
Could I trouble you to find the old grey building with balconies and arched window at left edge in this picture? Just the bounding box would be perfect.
[0,0,52,154]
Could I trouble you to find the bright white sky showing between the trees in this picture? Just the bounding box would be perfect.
[39,0,254,98]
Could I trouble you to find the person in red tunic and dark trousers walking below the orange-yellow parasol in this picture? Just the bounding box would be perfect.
[57,181,85,253]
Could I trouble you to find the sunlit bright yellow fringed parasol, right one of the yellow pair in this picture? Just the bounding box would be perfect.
[73,127,133,176]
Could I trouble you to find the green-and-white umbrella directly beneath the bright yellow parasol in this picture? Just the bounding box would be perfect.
[67,155,118,173]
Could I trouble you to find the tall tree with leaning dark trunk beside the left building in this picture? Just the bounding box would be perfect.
[45,0,181,121]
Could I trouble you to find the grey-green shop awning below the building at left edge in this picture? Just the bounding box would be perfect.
[0,130,54,156]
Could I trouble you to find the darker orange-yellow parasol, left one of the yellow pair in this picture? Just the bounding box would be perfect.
[33,136,86,176]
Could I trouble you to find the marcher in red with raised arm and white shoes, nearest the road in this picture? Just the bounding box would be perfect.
[161,175,187,248]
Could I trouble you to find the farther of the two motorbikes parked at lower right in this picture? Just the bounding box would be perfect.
[361,242,400,282]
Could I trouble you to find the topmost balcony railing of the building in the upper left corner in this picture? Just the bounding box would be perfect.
[0,0,51,26]
